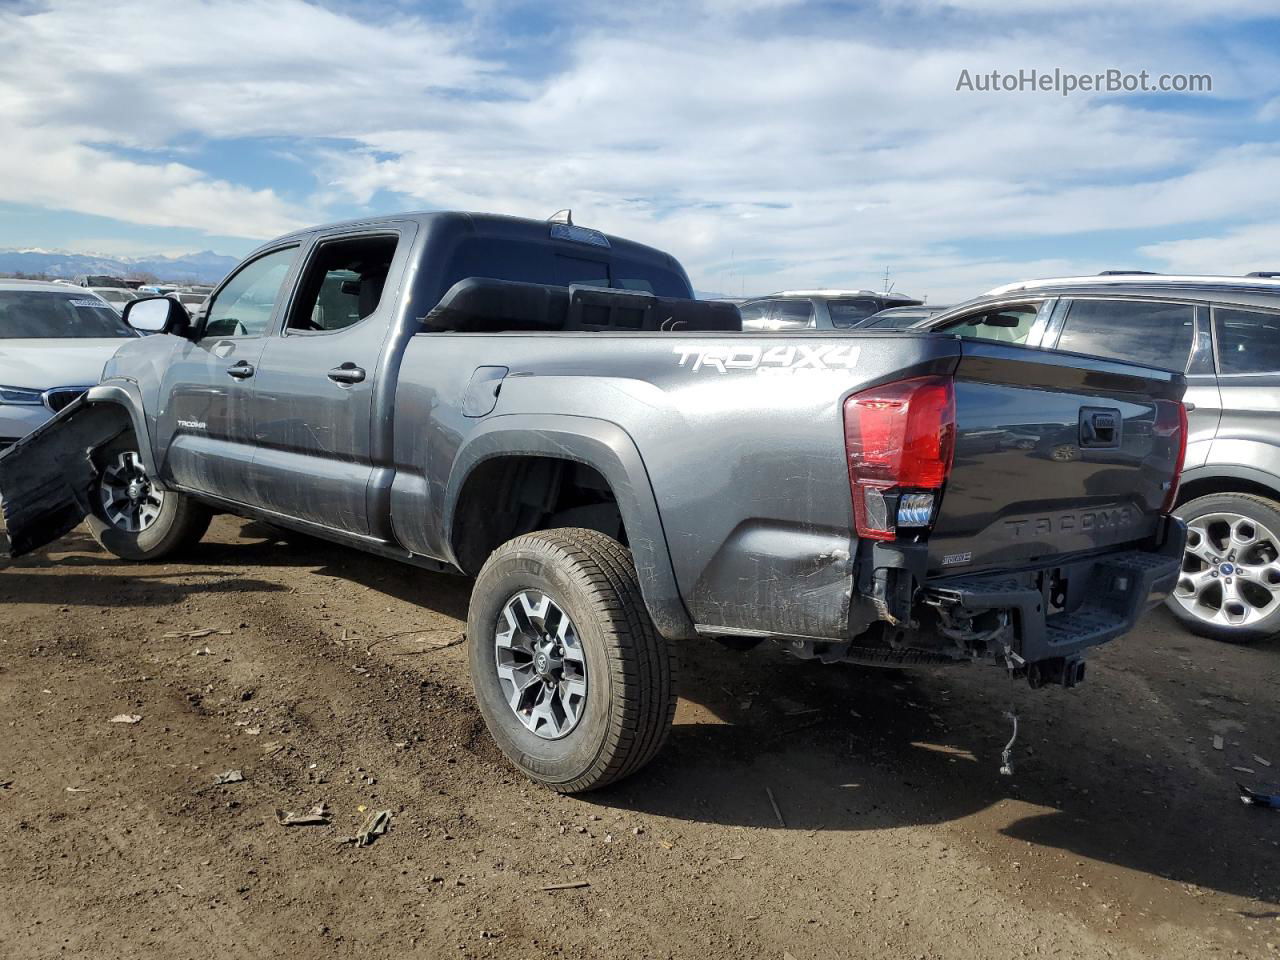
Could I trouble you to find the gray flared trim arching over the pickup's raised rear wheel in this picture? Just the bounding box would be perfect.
[443,413,696,640]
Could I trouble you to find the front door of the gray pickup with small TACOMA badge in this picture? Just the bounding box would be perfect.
[155,244,298,502]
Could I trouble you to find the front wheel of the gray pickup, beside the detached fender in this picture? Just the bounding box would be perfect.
[84,434,212,561]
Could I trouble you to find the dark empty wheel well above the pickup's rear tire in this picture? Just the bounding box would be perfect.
[449,456,627,575]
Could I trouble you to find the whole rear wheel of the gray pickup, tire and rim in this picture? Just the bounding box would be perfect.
[467,527,676,794]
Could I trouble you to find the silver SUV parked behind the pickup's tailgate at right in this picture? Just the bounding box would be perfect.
[919,274,1280,643]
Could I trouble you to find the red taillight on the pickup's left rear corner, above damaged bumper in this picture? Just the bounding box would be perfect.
[845,376,956,540]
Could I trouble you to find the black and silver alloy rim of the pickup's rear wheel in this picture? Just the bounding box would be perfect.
[494,590,586,740]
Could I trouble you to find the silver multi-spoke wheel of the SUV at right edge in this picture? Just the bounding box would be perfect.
[1174,513,1280,627]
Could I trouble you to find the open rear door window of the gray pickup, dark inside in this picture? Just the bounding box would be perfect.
[288,237,398,333]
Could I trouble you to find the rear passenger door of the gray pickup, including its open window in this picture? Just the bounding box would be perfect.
[244,225,412,536]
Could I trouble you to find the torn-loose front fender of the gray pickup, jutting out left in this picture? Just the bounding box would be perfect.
[0,383,156,558]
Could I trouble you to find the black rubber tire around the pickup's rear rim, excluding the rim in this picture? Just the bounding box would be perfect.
[467,527,676,794]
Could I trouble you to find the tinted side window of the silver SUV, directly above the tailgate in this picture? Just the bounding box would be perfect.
[1057,300,1196,372]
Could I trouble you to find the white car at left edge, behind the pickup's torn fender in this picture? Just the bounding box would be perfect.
[0,280,138,449]
